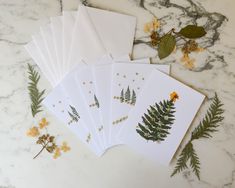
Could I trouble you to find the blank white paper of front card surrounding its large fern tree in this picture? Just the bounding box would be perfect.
[121,70,204,165]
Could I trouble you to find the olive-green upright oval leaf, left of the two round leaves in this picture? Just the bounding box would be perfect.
[158,34,176,59]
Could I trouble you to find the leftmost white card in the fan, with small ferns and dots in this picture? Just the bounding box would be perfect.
[43,85,103,156]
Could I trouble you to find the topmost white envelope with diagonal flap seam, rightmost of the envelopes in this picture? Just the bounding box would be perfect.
[68,6,136,70]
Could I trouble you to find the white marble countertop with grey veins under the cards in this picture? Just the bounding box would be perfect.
[0,0,235,188]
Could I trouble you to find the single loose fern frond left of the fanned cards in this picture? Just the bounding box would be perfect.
[28,64,45,117]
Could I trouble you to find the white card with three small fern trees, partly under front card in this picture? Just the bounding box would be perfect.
[109,61,169,144]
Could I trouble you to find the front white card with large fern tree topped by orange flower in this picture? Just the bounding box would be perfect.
[121,69,204,164]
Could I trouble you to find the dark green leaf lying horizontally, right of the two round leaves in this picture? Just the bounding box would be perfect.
[179,25,206,39]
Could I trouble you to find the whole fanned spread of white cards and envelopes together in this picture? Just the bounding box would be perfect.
[25,6,204,164]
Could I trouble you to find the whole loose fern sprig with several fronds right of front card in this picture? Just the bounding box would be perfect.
[171,93,224,179]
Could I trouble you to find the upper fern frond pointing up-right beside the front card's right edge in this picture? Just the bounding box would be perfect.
[191,94,224,140]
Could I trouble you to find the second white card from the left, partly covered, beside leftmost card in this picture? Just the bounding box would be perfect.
[60,64,105,151]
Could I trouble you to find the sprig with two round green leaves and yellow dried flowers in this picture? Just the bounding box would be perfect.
[144,18,206,68]
